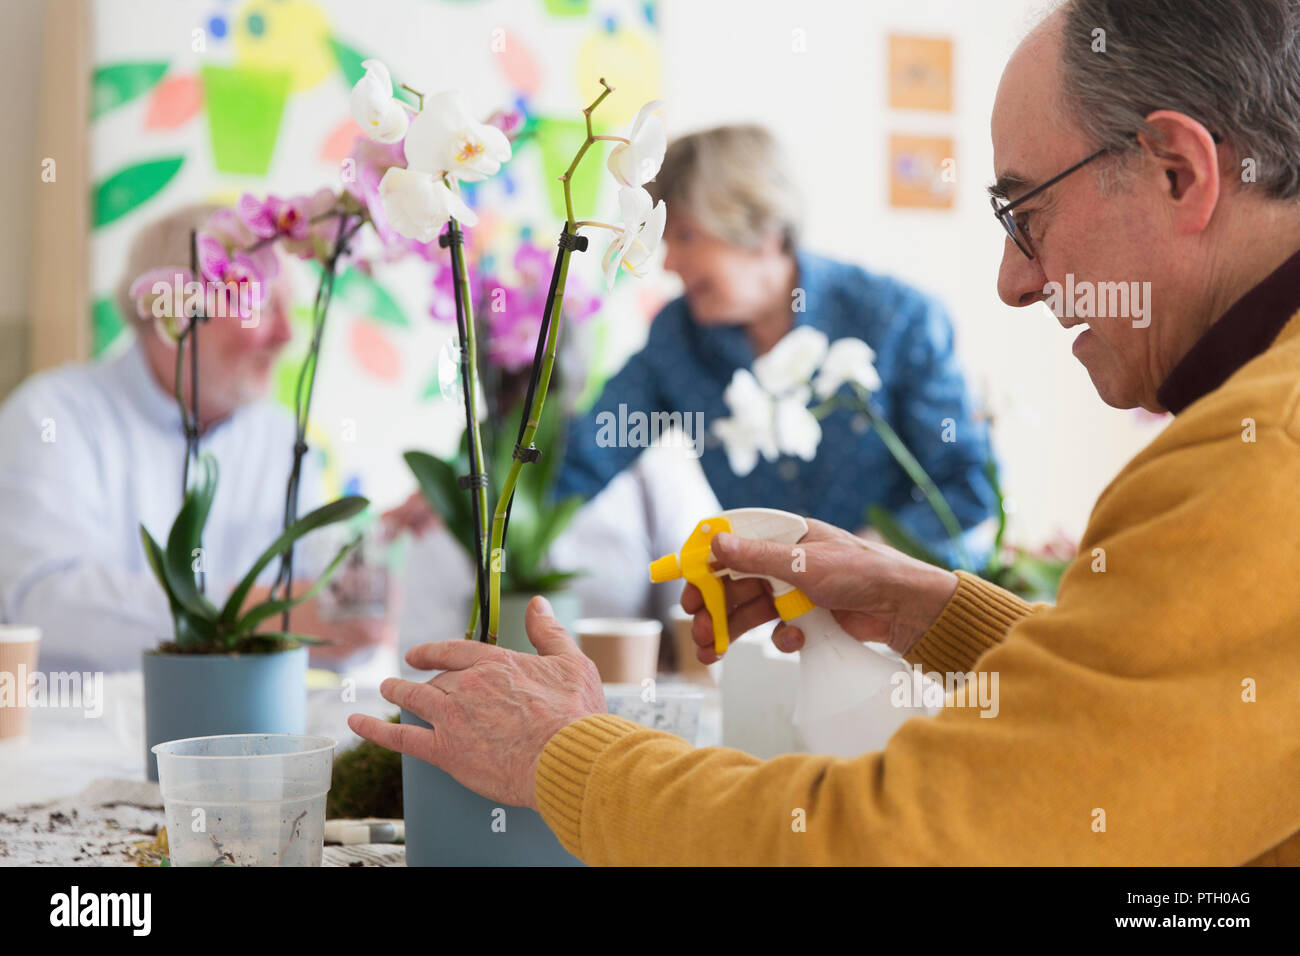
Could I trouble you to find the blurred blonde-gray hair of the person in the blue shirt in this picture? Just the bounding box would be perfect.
[646,124,801,252]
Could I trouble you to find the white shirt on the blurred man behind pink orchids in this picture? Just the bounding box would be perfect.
[0,343,320,671]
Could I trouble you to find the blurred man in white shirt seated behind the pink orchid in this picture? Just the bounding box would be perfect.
[0,204,395,671]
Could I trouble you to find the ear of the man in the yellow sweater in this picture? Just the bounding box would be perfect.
[1138,109,1222,235]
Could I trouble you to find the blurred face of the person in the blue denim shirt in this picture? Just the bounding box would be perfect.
[663,212,780,325]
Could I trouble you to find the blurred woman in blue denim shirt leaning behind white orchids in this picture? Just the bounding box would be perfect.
[558,126,995,559]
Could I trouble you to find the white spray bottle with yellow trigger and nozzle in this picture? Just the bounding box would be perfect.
[650,507,910,757]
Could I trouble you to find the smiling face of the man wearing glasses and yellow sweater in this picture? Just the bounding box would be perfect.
[991,14,1182,408]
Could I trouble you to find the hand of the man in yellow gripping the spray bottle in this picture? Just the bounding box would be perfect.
[681,519,957,663]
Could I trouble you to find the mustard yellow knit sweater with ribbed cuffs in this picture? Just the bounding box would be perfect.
[536,313,1300,866]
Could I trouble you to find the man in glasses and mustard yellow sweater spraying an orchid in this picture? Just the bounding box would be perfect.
[352,0,1300,865]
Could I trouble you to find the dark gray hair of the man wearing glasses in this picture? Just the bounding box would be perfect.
[1061,0,1300,200]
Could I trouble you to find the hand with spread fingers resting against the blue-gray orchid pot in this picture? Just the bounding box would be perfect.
[347,597,606,810]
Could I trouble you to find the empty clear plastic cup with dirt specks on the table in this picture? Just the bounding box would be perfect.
[152,734,337,866]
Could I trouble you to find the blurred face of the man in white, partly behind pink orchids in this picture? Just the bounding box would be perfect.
[199,272,293,414]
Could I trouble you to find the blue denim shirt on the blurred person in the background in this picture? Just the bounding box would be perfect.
[556,250,996,563]
